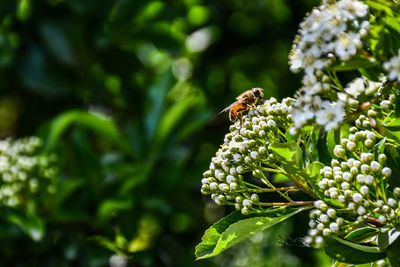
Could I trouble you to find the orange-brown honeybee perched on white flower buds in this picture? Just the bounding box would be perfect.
[220,88,264,126]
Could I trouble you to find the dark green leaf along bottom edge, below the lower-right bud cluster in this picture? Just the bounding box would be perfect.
[324,236,386,264]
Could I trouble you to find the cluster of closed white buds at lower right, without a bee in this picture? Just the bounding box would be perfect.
[305,127,400,247]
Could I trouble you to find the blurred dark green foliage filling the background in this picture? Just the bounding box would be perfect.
[0,0,328,266]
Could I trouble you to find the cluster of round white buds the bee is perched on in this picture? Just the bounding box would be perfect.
[201,98,294,214]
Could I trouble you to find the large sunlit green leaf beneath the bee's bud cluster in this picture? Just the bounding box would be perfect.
[195,208,308,259]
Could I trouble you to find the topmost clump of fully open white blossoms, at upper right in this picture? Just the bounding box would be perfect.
[289,0,370,75]
